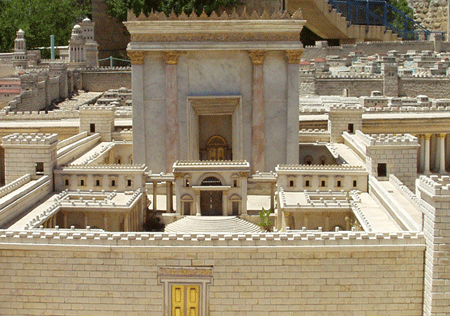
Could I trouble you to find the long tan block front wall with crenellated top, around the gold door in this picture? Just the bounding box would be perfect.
[0,230,424,316]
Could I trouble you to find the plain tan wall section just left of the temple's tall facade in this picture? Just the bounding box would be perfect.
[82,67,131,92]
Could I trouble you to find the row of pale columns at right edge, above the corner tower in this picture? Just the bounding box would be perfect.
[415,133,448,174]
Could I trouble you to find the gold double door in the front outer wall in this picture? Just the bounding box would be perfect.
[172,284,200,316]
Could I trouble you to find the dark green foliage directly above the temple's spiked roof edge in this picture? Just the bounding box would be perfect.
[105,0,240,21]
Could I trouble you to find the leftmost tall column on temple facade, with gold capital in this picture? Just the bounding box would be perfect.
[128,51,145,164]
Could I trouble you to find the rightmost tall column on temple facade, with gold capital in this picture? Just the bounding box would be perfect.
[284,49,303,164]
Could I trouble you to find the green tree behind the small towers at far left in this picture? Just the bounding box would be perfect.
[0,0,91,52]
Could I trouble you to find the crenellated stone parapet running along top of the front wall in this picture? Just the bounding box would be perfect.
[0,228,425,249]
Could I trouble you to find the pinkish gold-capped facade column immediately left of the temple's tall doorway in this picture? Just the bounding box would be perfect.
[164,51,180,172]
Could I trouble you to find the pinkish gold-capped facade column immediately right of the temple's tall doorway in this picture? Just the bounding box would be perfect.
[249,51,266,174]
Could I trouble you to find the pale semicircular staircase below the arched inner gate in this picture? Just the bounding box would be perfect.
[165,216,262,233]
